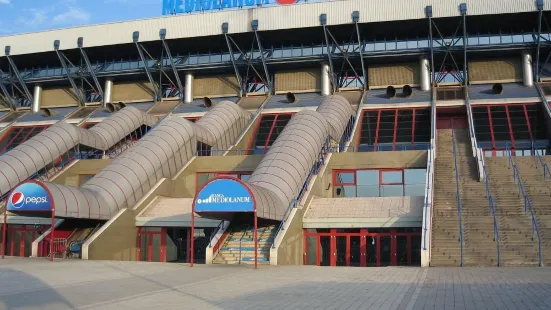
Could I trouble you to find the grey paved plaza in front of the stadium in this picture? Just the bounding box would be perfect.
[0,258,551,310]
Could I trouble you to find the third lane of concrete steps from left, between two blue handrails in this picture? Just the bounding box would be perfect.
[485,157,539,266]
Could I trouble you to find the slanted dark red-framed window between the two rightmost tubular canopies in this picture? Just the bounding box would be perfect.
[249,113,294,155]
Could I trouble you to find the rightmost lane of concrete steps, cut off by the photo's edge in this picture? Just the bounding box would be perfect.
[515,156,551,266]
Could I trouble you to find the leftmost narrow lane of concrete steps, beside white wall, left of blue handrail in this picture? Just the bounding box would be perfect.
[430,129,461,267]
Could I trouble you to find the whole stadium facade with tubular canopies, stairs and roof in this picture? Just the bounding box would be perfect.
[0,0,551,267]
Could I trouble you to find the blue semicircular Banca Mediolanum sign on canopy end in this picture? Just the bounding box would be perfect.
[195,179,254,212]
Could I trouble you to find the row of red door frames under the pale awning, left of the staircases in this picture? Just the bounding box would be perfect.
[303,228,421,267]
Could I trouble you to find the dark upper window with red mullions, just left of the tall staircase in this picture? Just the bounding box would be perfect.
[358,108,431,152]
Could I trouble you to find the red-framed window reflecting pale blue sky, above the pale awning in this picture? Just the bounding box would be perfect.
[333,168,426,198]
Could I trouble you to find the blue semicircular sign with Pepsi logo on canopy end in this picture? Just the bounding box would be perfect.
[8,182,52,211]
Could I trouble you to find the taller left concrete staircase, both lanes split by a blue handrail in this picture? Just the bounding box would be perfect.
[431,129,504,266]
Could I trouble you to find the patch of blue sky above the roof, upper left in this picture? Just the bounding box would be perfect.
[0,0,162,36]
